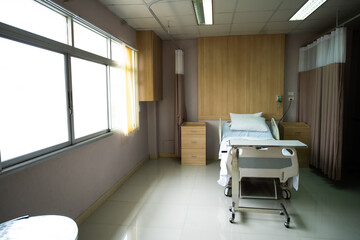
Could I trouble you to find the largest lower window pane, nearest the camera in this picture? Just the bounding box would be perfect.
[0,38,69,161]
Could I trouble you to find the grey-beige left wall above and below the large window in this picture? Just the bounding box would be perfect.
[0,0,148,222]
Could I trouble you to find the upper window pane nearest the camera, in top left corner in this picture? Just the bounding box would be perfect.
[0,0,68,44]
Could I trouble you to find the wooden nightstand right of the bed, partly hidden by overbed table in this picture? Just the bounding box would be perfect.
[279,122,311,168]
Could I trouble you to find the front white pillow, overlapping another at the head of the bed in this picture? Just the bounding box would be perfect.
[230,116,268,132]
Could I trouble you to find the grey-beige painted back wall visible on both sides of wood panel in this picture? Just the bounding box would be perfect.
[158,34,315,158]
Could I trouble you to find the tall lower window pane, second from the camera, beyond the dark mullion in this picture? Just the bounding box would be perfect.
[71,57,108,138]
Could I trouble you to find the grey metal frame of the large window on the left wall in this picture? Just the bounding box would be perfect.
[0,0,137,172]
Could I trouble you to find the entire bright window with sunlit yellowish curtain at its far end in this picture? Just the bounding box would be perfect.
[0,0,139,171]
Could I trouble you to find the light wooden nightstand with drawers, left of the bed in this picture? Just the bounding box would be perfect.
[181,122,206,165]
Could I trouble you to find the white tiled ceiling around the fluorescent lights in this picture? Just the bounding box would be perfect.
[99,0,360,40]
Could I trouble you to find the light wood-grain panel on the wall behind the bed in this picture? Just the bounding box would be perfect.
[198,35,285,120]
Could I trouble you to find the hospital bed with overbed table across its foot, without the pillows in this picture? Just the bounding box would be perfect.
[218,115,306,227]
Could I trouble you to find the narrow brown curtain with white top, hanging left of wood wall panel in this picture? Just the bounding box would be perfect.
[175,49,186,157]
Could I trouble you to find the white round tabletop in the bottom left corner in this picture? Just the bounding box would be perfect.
[0,215,78,240]
